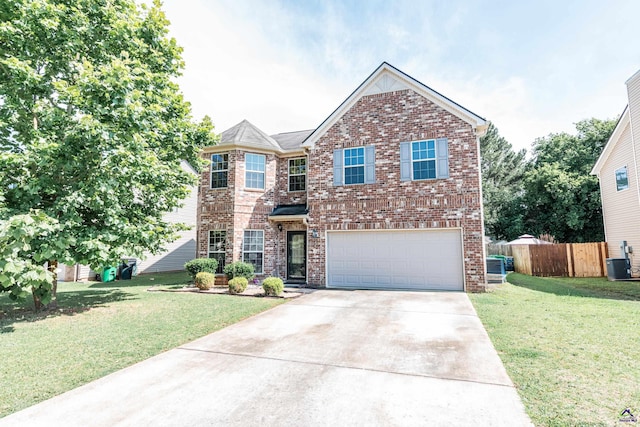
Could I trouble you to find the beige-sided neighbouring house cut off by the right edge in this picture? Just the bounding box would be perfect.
[591,67,640,276]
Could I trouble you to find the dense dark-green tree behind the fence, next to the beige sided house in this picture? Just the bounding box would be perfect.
[524,119,616,242]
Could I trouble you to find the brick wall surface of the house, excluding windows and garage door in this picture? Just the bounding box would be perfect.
[198,62,485,292]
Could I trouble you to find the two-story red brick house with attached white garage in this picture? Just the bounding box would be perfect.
[198,63,487,291]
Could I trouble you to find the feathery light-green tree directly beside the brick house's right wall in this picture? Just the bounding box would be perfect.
[480,123,527,240]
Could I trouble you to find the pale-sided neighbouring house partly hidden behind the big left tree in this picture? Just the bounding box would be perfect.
[58,161,198,281]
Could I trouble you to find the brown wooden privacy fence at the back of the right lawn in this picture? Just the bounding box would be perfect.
[511,242,607,277]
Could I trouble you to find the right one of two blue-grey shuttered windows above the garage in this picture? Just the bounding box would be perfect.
[400,138,449,181]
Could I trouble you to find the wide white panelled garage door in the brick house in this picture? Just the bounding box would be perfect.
[327,229,464,291]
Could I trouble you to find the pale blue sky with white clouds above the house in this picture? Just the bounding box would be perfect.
[163,0,640,153]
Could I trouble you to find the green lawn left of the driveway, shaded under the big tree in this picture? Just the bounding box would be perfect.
[0,273,283,417]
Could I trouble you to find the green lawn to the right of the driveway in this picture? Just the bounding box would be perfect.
[470,273,640,426]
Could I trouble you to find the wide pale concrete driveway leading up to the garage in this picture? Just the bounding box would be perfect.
[0,290,530,426]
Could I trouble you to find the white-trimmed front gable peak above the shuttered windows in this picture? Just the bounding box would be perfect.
[303,62,488,147]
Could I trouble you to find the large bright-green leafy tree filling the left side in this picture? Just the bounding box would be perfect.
[0,0,215,310]
